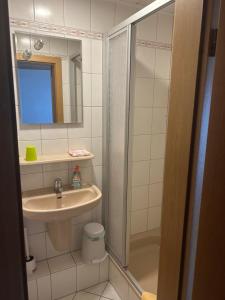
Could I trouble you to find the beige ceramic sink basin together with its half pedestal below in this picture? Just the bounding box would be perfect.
[23,185,102,251]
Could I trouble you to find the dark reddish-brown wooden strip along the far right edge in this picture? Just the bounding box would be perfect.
[183,0,225,300]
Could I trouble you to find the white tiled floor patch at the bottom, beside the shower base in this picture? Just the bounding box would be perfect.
[59,281,120,300]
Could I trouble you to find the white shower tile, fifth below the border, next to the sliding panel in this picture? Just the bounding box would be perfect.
[132,161,149,186]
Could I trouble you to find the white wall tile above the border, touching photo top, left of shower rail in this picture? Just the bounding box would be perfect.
[91,0,116,32]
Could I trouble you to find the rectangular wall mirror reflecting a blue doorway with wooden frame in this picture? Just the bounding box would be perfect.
[15,33,83,125]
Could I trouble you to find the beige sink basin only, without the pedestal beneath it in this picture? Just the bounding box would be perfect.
[23,185,102,223]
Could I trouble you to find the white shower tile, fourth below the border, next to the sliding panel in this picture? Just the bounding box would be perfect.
[132,135,151,161]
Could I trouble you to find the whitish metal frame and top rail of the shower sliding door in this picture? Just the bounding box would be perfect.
[103,0,175,282]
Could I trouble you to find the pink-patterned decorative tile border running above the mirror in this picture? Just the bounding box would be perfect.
[10,18,103,40]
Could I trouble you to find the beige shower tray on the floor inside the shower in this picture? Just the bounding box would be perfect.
[128,231,160,294]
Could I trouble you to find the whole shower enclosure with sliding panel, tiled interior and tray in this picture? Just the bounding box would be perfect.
[103,0,174,293]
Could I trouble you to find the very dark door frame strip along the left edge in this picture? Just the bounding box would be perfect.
[0,0,28,300]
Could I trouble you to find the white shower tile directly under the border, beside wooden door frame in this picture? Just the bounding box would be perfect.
[155,49,171,79]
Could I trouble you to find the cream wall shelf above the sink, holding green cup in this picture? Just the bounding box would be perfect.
[20,153,95,166]
